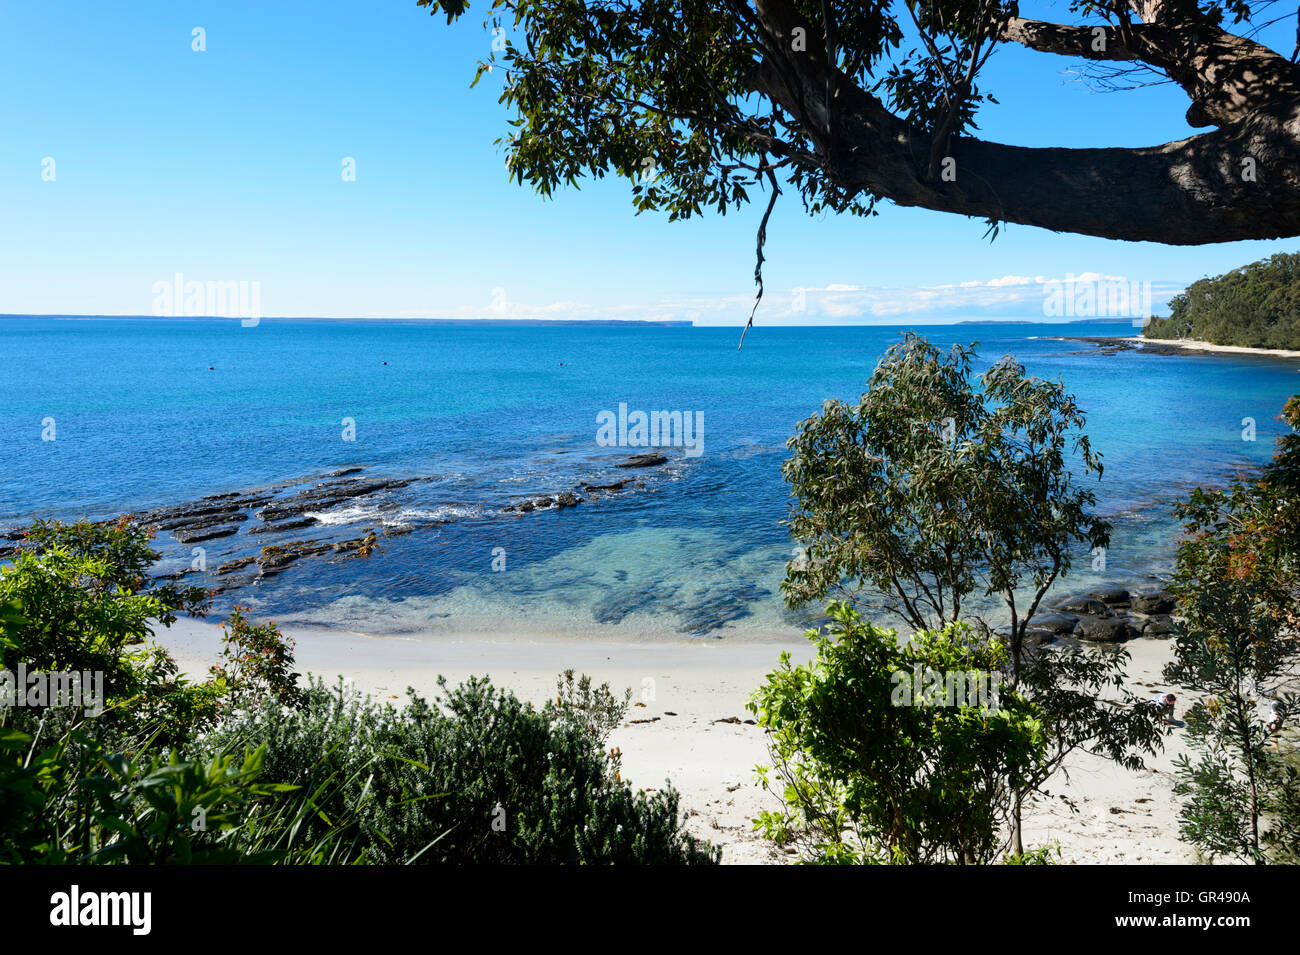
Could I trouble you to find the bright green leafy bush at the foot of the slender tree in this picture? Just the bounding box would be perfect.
[750,603,1047,864]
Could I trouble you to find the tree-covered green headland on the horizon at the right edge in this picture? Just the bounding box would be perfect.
[1143,252,1300,348]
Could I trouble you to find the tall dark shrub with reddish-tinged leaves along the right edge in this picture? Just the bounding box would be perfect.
[1165,398,1300,864]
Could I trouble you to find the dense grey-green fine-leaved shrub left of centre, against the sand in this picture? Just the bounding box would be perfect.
[207,680,719,864]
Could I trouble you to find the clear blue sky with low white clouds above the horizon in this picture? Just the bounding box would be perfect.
[0,0,1295,325]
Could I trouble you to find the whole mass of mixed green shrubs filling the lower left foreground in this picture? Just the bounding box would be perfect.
[0,520,718,864]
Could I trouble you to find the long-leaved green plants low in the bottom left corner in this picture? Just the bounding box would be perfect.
[0,728,364,865]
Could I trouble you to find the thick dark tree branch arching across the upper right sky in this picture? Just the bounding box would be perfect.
[749,0,1300,246]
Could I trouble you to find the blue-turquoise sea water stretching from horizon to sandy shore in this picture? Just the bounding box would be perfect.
[0,318,1300,637]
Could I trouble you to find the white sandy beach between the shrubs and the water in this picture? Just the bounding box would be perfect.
[157,620,1195,864]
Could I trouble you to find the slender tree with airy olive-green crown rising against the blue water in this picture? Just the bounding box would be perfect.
[764,334,1160,855]
